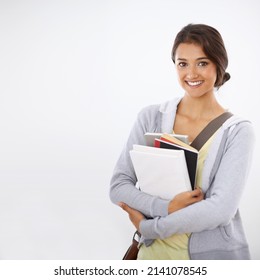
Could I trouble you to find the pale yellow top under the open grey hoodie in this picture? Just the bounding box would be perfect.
[137,135,214,260]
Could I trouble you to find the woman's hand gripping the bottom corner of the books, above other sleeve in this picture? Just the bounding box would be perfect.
[168,188,204,214]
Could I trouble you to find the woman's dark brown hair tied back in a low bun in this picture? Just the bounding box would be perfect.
[172,24,230,88]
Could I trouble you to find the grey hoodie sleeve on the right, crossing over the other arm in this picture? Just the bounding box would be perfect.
[140,123,254,239]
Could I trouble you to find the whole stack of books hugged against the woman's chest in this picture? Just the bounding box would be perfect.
[130,133,198,199]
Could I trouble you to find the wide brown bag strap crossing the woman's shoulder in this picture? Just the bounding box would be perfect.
[190,112,233,151]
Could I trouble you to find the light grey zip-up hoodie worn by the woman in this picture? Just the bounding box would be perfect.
[110,97,254,260]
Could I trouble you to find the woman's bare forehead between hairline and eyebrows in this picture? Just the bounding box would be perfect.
[175,43,207,60]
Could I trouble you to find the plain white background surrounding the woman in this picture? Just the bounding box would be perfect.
[0,0,260,260]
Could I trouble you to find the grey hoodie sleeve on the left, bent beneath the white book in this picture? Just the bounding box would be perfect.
[110,106,169,217]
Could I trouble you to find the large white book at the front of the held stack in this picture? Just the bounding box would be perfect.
[130,145,192,199]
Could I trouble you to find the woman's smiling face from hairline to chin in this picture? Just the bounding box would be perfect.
[175,43,217,97]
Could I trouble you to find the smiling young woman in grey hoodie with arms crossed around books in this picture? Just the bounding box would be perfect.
[110,24,254,259]
